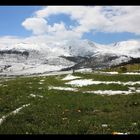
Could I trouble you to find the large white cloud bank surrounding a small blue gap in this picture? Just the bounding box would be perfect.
[0,6,140,44]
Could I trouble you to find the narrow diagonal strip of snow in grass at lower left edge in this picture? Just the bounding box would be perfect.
[0,104,30,125]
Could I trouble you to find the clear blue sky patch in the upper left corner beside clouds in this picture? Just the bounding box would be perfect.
[0,6,41,37]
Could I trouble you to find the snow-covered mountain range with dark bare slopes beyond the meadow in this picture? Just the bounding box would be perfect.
[0,40,140,75]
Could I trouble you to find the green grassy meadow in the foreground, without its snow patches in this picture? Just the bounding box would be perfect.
[0,73,140,134]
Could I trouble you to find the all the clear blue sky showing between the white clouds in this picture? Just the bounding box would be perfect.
[0,6,140,44]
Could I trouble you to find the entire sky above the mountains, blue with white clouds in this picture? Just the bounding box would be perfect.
[0,6,140,44]
